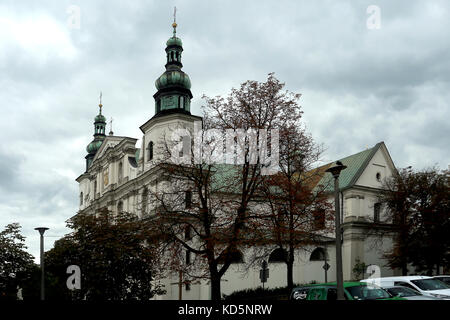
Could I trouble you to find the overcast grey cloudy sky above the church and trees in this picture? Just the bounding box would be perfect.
[0,0,450,257]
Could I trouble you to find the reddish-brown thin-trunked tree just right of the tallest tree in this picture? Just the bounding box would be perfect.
[258,123,333,289]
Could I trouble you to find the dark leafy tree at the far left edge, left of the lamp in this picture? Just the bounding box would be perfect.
[0,223,35,300]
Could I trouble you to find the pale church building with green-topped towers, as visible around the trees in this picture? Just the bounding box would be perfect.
[76,24,395,300]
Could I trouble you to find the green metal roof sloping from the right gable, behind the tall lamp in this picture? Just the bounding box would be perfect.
[317,142,382,192]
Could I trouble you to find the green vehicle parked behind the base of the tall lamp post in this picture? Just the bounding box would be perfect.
[305,282,406,300]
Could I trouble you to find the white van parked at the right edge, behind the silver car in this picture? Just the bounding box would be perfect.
[361,276,450,300]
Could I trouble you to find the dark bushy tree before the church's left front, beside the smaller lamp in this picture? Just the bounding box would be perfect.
[42,210,163,300]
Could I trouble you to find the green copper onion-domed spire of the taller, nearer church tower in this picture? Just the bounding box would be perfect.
[153,21,192,117]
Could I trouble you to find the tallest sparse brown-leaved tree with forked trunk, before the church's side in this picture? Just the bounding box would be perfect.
[150,74,312,300]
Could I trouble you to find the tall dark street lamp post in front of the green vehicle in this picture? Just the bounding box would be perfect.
[326,161,347,300]
